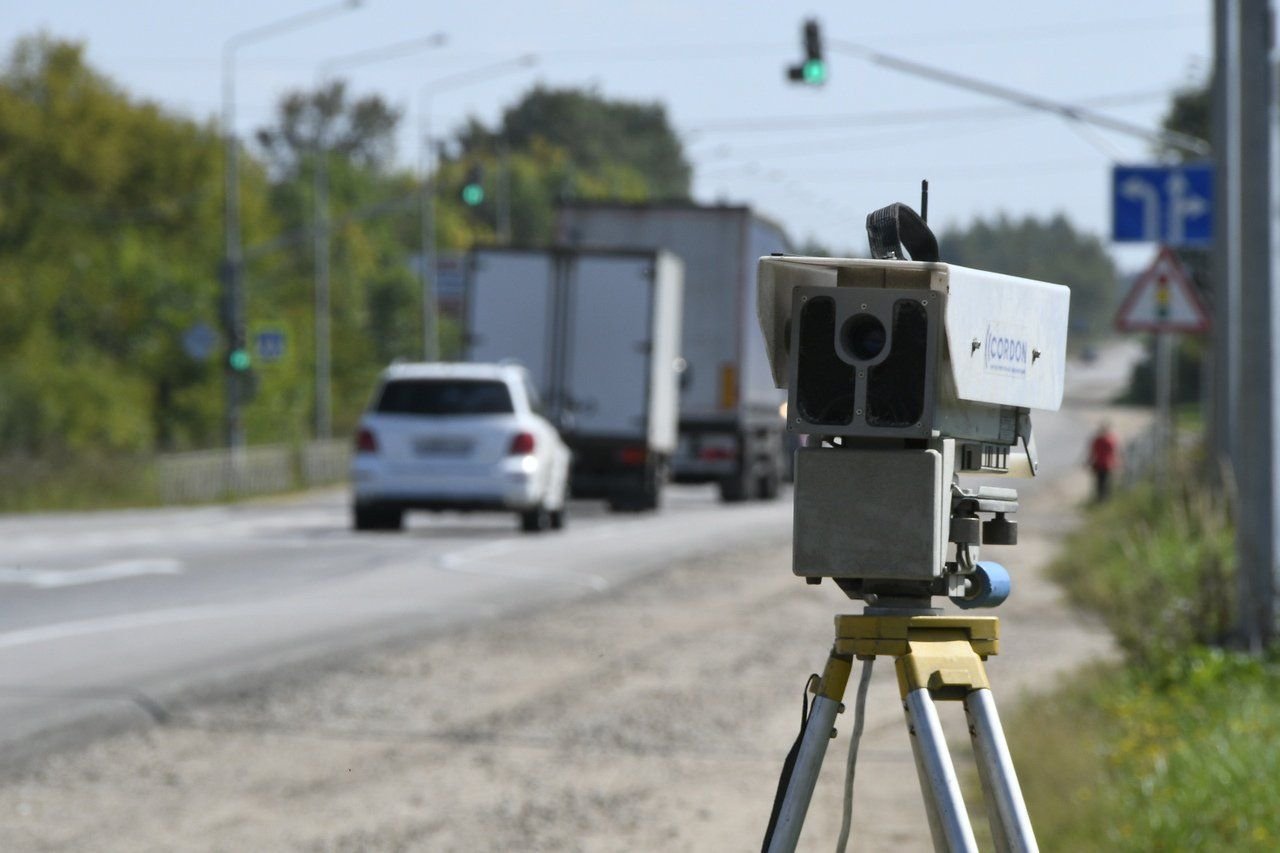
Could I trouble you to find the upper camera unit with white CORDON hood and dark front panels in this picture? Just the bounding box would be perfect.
[758,256,1070,458]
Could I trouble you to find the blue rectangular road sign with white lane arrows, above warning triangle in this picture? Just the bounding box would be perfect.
[1111,163,1213,248]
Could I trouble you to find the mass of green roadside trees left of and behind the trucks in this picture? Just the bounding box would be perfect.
[0,37,690,494]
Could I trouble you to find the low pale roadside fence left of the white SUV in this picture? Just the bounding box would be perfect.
[156,441,351,503]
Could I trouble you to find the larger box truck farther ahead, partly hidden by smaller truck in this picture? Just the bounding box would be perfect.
[556,202,790,501]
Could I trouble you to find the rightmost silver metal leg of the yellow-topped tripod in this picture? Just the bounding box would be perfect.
[964,688,1039,853]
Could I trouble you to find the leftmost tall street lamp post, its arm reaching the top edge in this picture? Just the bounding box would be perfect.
[219,0,361,450]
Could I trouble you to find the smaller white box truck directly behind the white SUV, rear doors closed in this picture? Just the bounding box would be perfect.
[465,248,684,511]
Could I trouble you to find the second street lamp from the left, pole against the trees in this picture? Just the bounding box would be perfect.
[311,32,448,439]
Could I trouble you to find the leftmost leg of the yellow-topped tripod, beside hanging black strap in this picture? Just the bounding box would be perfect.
[767,652,852,853]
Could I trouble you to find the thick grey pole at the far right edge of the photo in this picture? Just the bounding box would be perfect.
[1225,0,1280,652]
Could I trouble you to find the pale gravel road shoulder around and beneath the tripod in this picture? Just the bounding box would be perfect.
[0,409,1140,852]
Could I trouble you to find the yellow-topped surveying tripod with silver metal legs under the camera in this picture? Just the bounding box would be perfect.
[765,610,1038,853]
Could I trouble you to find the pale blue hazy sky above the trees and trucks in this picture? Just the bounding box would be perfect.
[0,0,1212,270]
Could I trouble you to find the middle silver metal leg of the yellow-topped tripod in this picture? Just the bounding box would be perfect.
[902,688,978,853]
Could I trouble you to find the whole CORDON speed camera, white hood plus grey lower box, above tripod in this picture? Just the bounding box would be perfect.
[756,256,1070,599]
